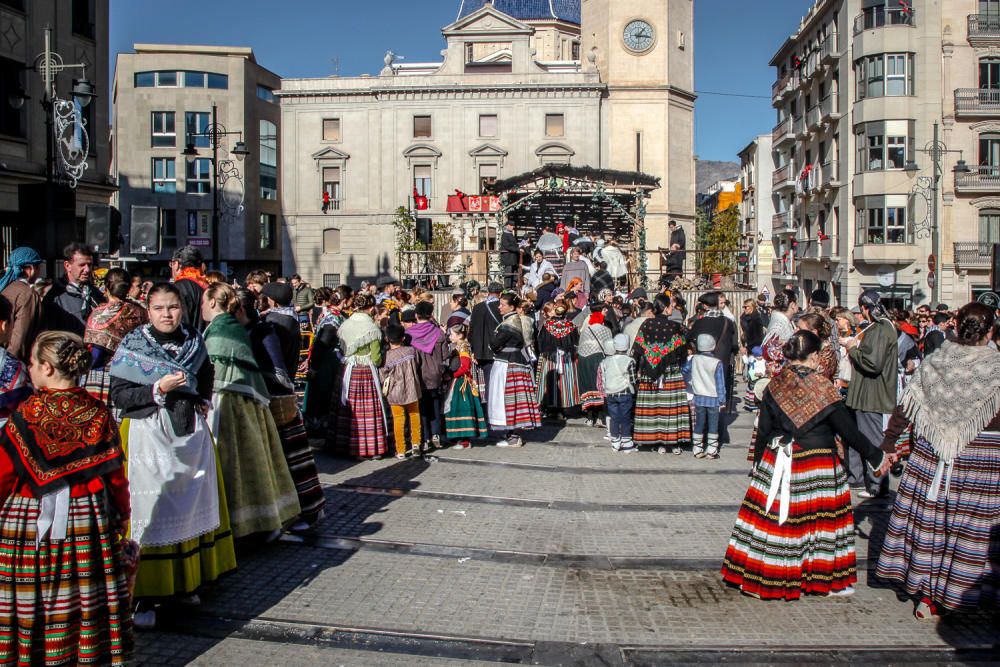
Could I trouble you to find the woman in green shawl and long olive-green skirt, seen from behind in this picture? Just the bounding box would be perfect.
[201,283,301,539]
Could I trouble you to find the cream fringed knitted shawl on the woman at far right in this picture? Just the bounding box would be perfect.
[900,342,1000,461]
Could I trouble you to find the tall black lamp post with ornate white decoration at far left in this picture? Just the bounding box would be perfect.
[7,27,97,276]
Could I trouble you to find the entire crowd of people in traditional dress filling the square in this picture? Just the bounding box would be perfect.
[0,234,1000,664]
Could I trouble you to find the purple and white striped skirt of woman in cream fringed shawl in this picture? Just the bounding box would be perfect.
[876,431,1000,609]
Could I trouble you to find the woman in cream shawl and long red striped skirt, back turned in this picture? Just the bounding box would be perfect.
[337,294,388,459]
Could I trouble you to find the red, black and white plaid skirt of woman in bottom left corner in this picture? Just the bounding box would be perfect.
[0,495,132,665]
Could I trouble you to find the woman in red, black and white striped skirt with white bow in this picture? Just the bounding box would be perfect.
[722,331,889,600]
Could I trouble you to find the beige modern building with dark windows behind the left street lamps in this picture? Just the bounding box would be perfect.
[113,44,282,278]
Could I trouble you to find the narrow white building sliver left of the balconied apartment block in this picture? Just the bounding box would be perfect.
[739,134,777,294]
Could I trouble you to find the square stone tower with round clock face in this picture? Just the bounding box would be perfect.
[581,0,695,269]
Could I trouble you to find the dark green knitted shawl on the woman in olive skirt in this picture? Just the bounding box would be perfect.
[205,313,271,405]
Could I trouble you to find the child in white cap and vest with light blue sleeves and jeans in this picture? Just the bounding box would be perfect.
[682,334,726,459]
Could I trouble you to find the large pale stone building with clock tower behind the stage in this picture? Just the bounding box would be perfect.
[277,0,694,285]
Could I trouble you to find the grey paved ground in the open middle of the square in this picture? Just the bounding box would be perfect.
[137,400,1000,667]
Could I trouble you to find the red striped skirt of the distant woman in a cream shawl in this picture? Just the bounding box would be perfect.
[337,364,388,458]
